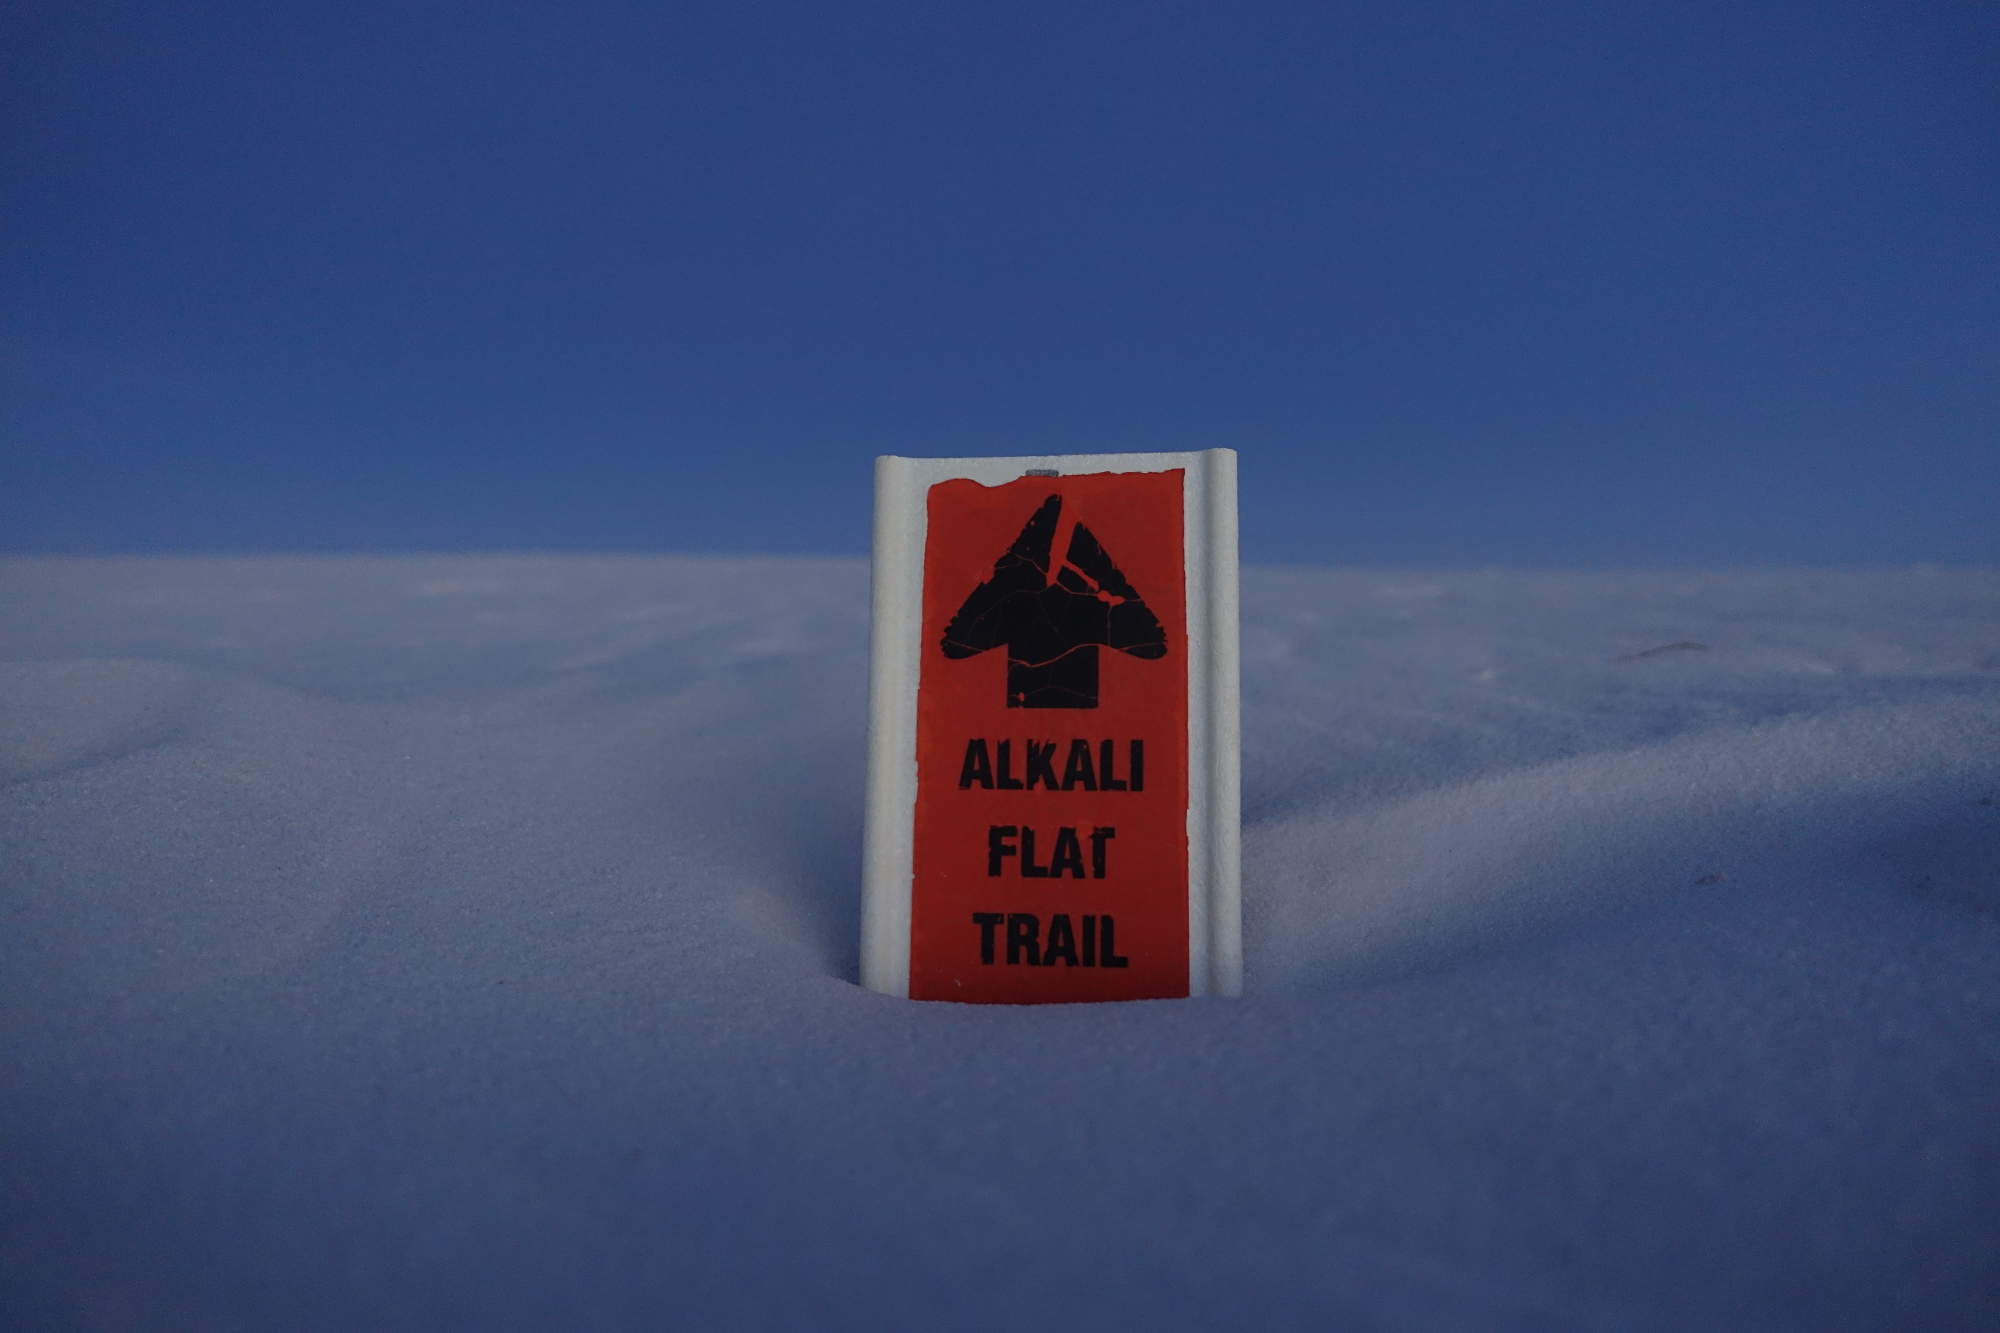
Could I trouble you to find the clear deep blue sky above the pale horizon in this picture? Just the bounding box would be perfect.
[0,0,2000,566]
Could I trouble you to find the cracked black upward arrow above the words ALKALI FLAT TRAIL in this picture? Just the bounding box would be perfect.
[942,494,1166,709]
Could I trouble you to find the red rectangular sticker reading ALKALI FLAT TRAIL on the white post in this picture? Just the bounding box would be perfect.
[910,468,1188,1003]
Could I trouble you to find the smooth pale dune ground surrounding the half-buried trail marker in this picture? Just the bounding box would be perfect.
[0,558,2000,1329]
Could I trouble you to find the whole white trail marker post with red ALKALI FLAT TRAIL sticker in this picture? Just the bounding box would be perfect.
[862,448,1242,1003]
